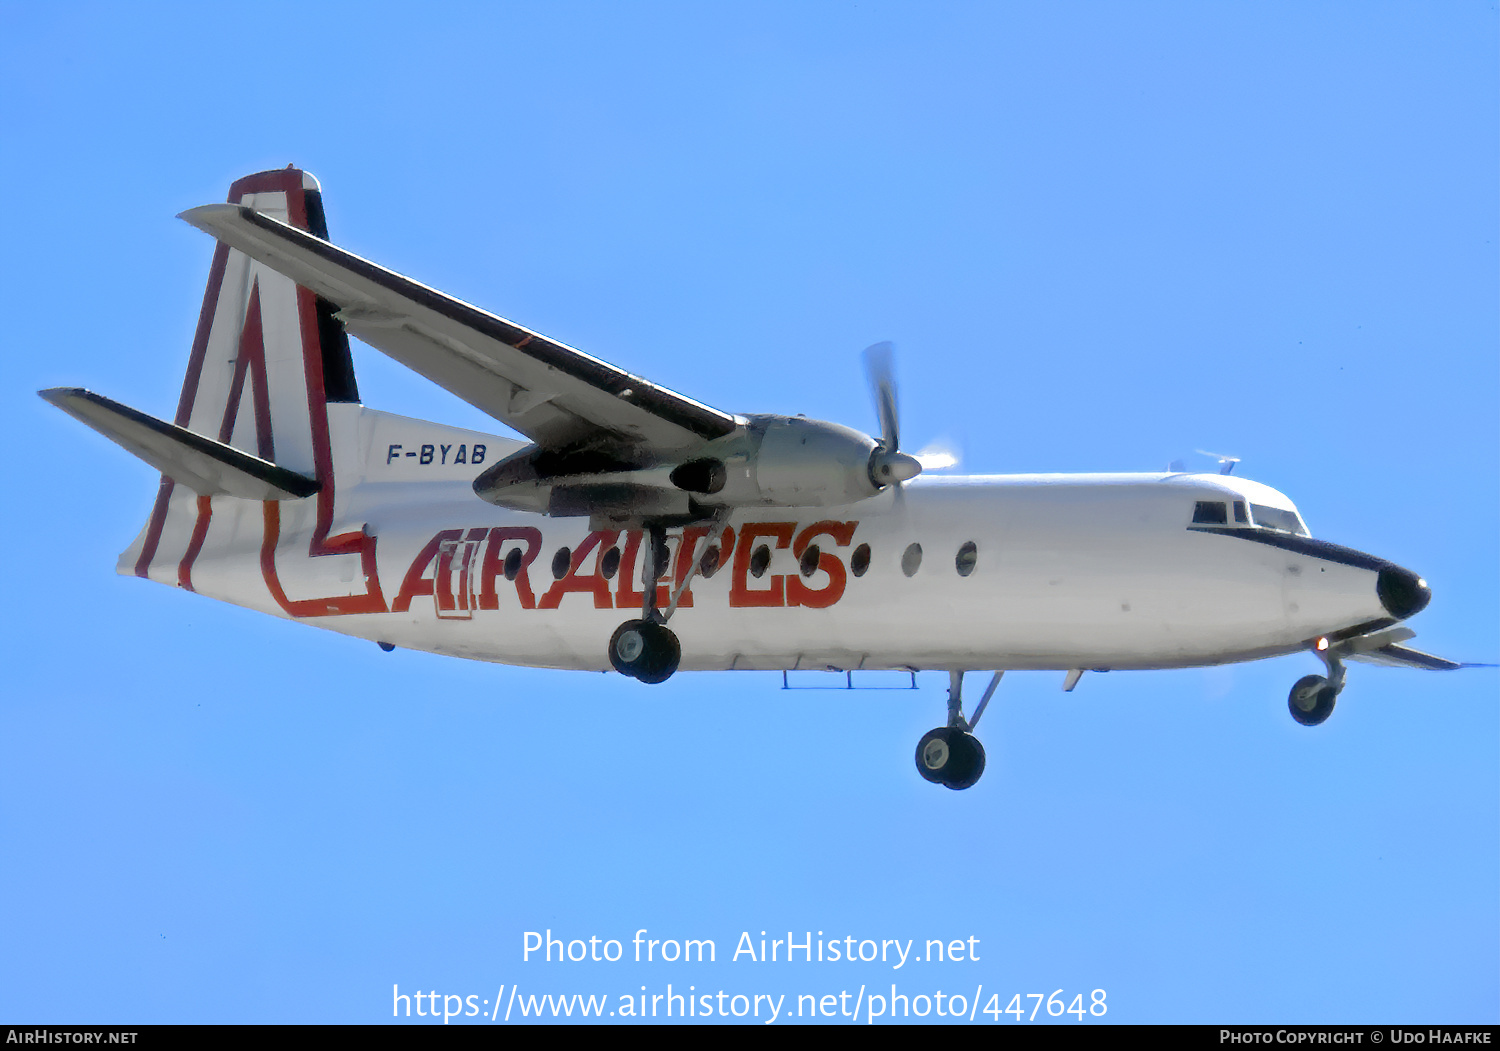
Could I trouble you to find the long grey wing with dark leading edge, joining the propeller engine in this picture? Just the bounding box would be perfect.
[180,204,743,455]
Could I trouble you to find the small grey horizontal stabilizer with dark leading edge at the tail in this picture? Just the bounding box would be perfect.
[38,387,320,501]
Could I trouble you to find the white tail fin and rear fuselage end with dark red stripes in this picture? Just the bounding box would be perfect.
[119,166,386,616]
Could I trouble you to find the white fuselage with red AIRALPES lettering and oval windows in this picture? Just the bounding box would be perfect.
[141,406,1391,670]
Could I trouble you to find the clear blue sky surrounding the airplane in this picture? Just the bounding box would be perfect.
[0,1,1500,1024]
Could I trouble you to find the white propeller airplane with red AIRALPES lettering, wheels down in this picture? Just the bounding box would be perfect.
[39,166,1469,789]
